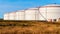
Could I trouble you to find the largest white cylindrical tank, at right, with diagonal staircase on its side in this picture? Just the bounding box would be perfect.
[39,4,60,20]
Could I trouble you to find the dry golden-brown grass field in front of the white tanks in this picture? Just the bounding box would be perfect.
[0,20,60,34]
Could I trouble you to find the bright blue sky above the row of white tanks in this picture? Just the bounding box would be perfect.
[0,0,60,18]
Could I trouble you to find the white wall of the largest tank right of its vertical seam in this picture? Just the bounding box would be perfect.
[47,7,60,19]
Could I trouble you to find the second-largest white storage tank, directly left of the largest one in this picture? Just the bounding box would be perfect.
[25,8,38,20]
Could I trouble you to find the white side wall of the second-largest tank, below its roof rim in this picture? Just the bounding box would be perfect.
[25,10,36,20]
